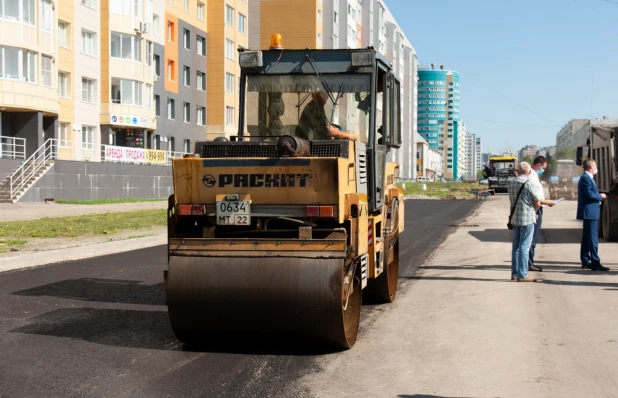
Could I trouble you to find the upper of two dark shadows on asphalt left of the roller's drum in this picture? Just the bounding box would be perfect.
[13,278,165,305]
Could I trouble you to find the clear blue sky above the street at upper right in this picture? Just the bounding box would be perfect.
[385,0,618,153]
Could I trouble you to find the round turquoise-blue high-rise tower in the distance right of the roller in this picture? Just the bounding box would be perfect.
[418,64,465,178]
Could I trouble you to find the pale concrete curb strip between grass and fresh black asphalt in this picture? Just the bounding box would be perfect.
[0,233,167,273]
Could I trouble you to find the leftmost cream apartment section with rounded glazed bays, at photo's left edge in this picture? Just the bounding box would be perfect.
[0,0,60,153]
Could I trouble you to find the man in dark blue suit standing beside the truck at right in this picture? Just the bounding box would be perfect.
[577,159,609,271]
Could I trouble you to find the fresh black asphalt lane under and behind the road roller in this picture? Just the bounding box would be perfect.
[0,200,478,397]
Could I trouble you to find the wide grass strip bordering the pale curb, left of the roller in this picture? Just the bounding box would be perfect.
[0,209,167,240]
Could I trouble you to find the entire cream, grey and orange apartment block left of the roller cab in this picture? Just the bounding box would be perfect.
[0,0,248,161]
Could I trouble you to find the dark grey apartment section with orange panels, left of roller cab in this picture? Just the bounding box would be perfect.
[149,0,208,152]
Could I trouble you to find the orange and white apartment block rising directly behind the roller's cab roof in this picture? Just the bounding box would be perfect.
[249,0,418,180]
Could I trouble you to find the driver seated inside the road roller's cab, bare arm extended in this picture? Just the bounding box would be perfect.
[296,91,356,141]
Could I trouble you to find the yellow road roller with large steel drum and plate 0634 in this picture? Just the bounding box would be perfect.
[164,39,404,349]
